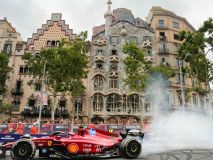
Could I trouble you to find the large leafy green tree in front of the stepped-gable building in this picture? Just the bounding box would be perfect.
[23,32,88,120]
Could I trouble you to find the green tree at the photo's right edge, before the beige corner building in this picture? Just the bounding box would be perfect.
[178,18,213,90]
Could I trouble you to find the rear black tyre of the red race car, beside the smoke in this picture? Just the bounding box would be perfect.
[119,138,142,159]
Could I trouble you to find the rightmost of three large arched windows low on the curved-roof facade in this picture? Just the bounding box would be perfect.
[128,94,140,113]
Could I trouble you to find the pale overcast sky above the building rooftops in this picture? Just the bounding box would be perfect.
[0,0,213,40]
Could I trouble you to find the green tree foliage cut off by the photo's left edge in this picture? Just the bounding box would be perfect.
[0,52,12,94]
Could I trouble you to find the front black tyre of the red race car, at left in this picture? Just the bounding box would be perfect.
[10,138,36,160]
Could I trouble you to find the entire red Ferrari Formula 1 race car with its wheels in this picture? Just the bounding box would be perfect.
[0,128,143,160]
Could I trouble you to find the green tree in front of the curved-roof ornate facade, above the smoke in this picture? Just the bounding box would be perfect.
[123,43,175,92]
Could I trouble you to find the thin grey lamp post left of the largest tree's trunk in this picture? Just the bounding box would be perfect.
[38,61,46,133]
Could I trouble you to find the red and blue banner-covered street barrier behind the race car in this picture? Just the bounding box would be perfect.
[0,123,141,143]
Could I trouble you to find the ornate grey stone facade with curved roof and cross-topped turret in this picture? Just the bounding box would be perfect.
[88,1,155,124]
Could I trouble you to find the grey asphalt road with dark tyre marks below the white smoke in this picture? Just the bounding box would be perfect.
[2,149,213,160]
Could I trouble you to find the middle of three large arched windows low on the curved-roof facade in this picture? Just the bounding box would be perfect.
[106,94,121,113]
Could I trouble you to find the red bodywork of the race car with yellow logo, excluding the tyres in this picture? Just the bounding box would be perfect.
[0,128,143,160]
